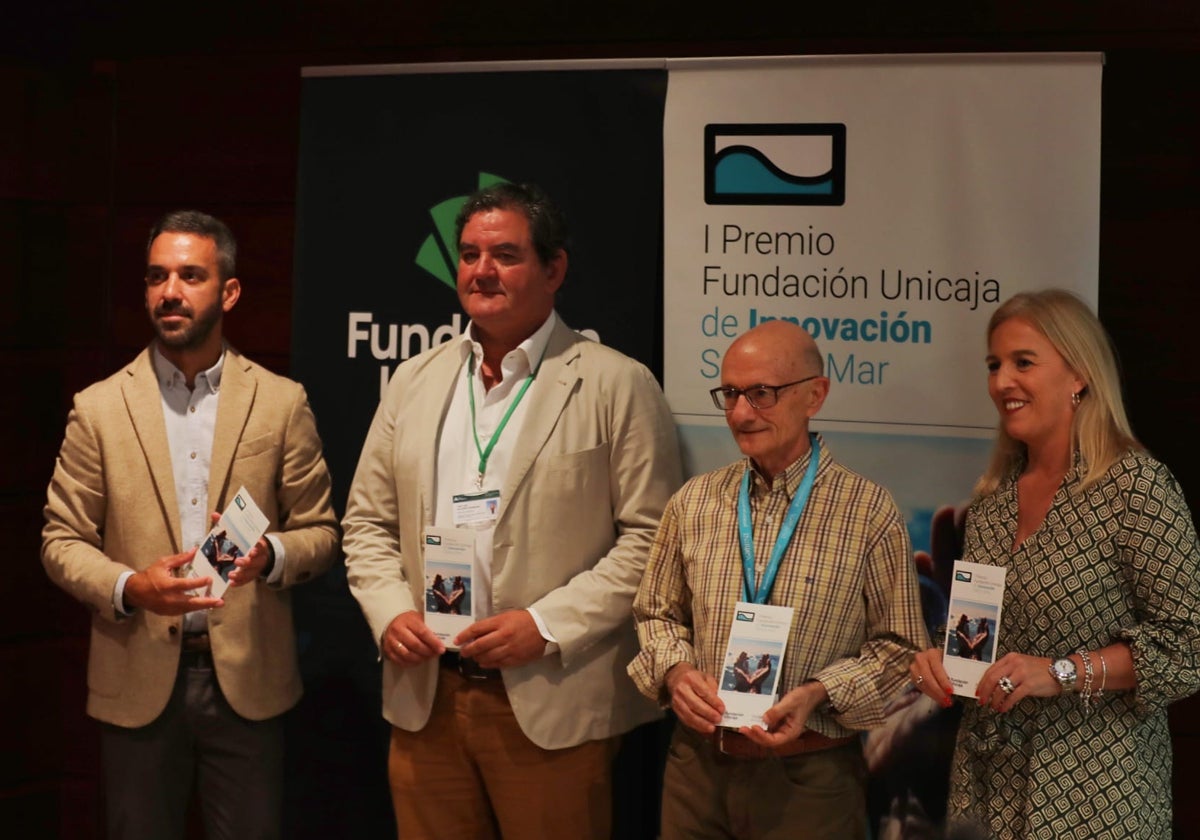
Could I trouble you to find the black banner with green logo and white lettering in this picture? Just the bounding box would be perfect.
[286,68,666,838]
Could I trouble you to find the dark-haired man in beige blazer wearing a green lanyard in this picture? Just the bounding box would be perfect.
[343,185,680,840]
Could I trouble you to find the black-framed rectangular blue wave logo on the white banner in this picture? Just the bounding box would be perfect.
[704,122,846,205]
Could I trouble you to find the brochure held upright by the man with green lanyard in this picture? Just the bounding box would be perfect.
[425,528,476,650]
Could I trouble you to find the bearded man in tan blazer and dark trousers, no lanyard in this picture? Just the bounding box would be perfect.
[42,211,338,838]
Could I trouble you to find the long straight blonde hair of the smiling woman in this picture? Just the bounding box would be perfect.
[974,289,1142,496]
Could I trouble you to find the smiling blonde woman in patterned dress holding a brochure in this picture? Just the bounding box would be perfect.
[911,290,1200,840]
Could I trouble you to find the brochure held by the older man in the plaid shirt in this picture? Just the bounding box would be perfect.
[718,601,796,728]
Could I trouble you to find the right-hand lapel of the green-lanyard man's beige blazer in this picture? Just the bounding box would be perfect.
[500,320,586,506]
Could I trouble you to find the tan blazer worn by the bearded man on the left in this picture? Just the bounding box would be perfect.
[42,349,338,727]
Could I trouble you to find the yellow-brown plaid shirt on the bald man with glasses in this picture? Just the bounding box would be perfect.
[629,440,929,737]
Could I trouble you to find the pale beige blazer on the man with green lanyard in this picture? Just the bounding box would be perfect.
[343,322,682,749]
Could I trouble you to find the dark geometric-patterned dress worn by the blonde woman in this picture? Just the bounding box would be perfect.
[949,452,1200,840]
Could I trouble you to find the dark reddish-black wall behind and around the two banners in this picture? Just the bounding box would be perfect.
[0,0,1200,838]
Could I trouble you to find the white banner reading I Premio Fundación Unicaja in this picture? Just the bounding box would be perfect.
[664,54,1100,511]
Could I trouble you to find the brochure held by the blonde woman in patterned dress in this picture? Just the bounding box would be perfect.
[942,560,1008,697]
